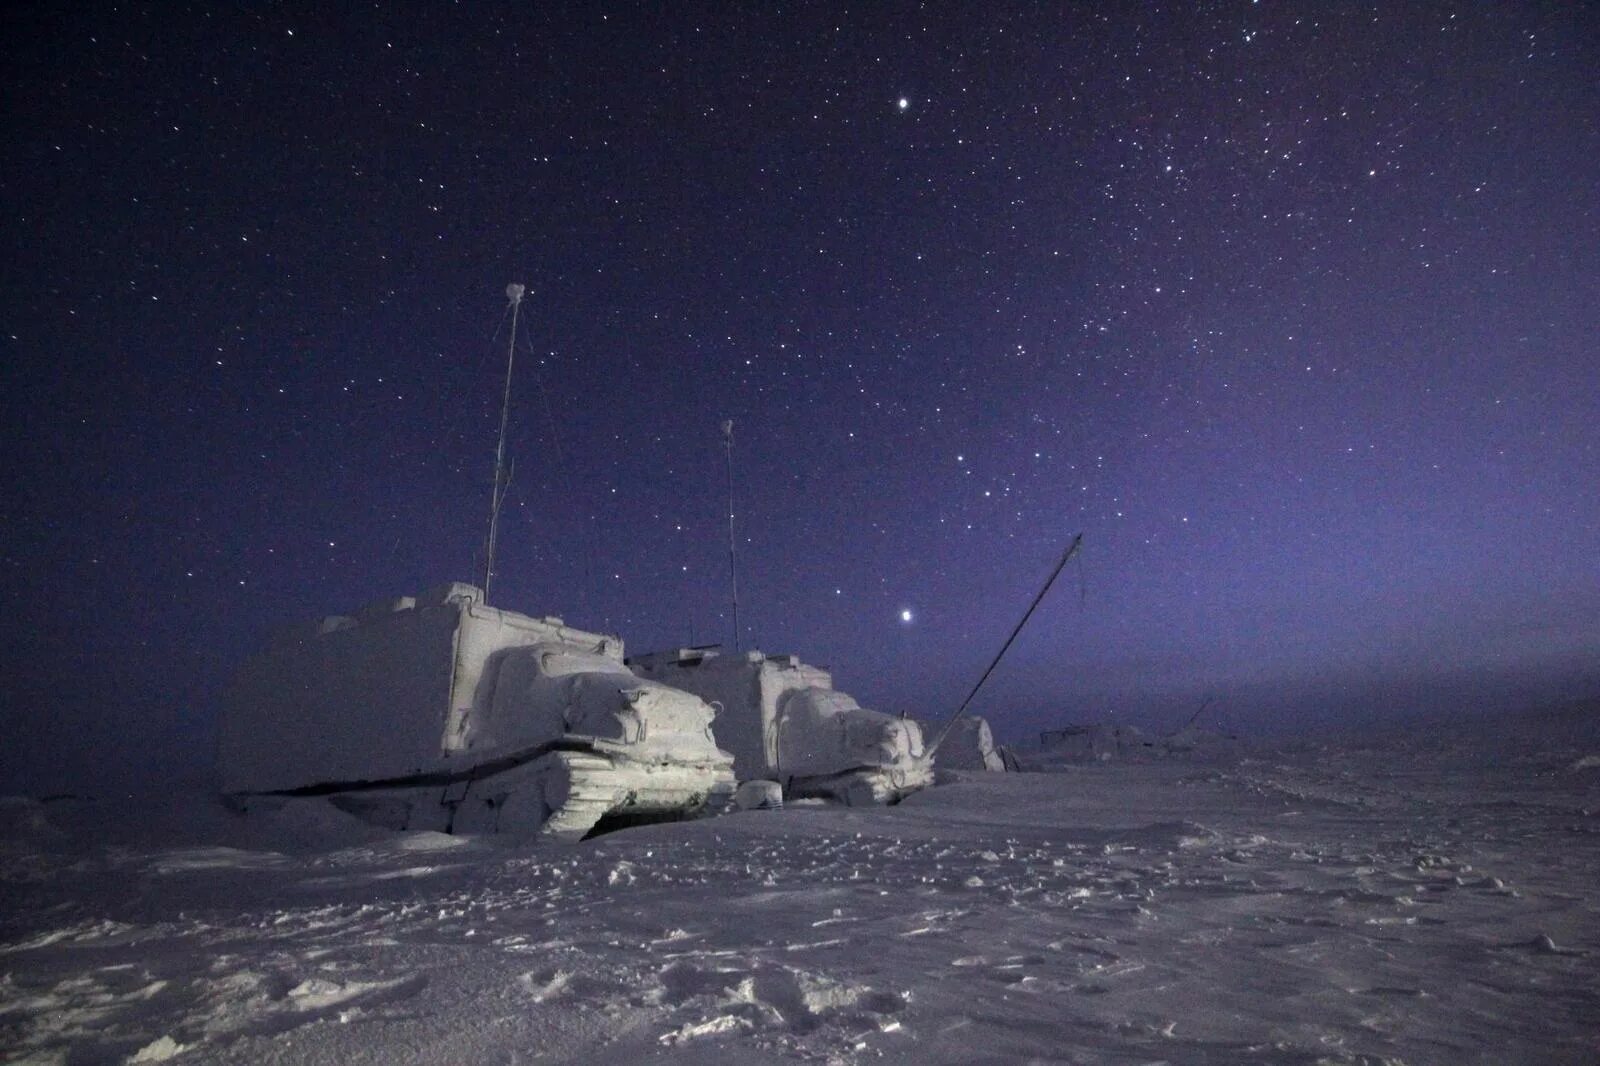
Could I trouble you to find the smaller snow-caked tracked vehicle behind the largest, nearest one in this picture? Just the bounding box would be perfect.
[629,647,933,804]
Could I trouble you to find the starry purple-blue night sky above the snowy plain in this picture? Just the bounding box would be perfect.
[0,3,1600,791]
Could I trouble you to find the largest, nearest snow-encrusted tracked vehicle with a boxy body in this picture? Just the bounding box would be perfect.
[218,584,734,840]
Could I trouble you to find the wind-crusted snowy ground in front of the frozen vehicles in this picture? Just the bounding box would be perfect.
[0,738,1600,1064]
